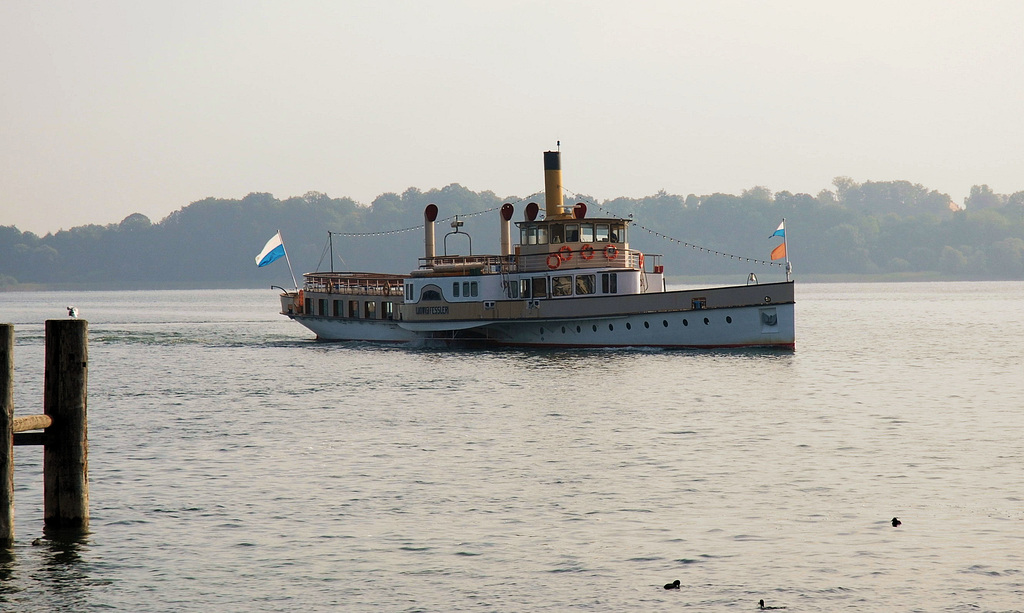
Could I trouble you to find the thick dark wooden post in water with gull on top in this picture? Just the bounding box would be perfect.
[43,319,89,530]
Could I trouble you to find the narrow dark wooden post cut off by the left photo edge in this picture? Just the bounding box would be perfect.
[0,323,14,549]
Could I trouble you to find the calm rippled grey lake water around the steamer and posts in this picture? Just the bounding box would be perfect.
[0,283,1024,612]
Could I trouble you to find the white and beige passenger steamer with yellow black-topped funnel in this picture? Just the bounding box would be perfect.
[281,150,796,350]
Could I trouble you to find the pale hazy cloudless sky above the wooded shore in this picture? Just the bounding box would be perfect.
[0,0,1024,234]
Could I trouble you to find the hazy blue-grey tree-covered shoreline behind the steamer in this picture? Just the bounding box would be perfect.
[0,177,1024,290]
